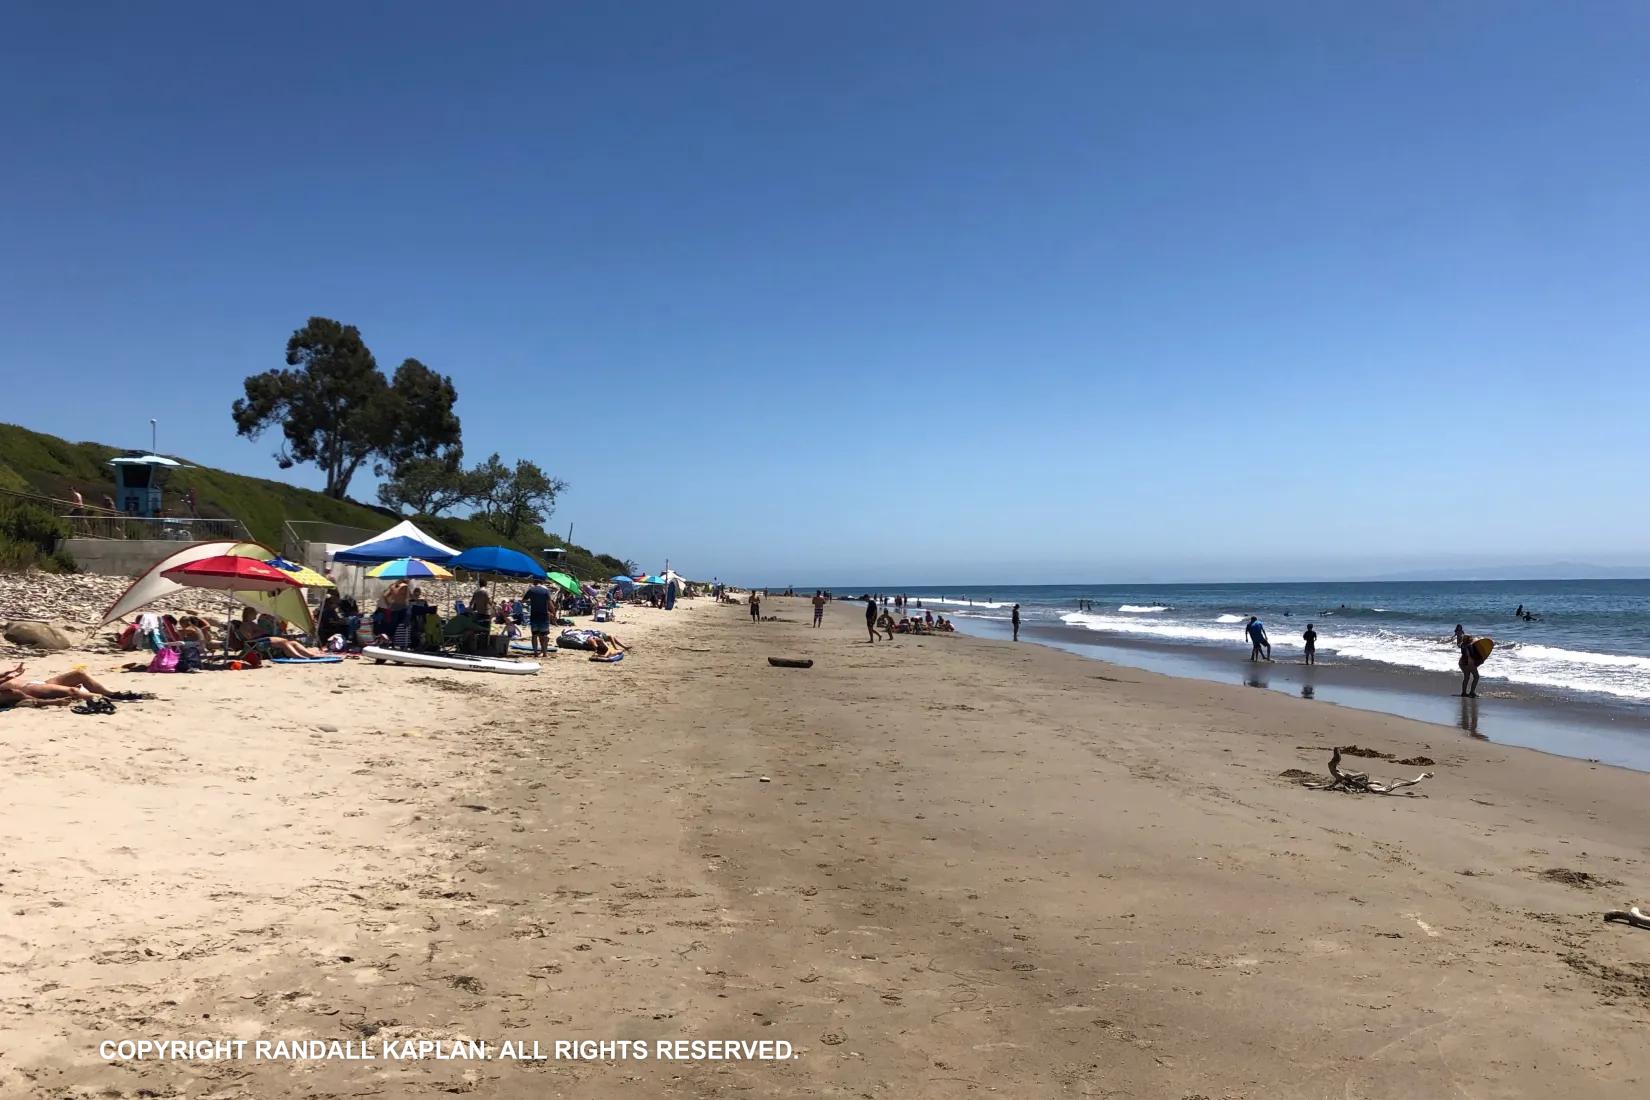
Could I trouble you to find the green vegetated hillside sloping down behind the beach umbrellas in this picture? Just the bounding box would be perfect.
[0,424,624,581]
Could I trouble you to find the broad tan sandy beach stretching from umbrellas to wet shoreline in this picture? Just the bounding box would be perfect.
[0,599,1650,1100]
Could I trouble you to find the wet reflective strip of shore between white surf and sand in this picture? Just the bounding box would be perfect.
[950,615,1650,772]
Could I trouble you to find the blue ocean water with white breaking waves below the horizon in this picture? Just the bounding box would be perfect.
[864,581,1650,712]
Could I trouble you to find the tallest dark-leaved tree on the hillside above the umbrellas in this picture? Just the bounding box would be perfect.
[233,317,459,498]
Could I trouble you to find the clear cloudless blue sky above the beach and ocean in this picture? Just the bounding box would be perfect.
[0,0,1650,584]
